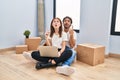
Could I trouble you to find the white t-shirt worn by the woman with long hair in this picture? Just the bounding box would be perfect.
[49,32,68,48]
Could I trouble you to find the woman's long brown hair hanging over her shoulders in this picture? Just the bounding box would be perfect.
[50,18,62,37]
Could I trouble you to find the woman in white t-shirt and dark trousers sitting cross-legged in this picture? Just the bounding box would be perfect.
[23,18,72,69]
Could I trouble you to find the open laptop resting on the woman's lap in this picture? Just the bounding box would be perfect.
[38,46,59,57]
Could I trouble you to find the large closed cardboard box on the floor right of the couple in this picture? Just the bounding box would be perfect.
[77,43,105,66]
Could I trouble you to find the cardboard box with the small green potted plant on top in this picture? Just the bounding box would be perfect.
[25,37,41,51]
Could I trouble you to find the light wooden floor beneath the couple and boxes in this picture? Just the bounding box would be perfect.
[0,51,120,80]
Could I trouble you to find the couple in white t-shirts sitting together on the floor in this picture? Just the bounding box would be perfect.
[23,16,76,75]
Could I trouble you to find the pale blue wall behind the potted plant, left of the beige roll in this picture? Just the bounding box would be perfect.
[0,0,37,49]
